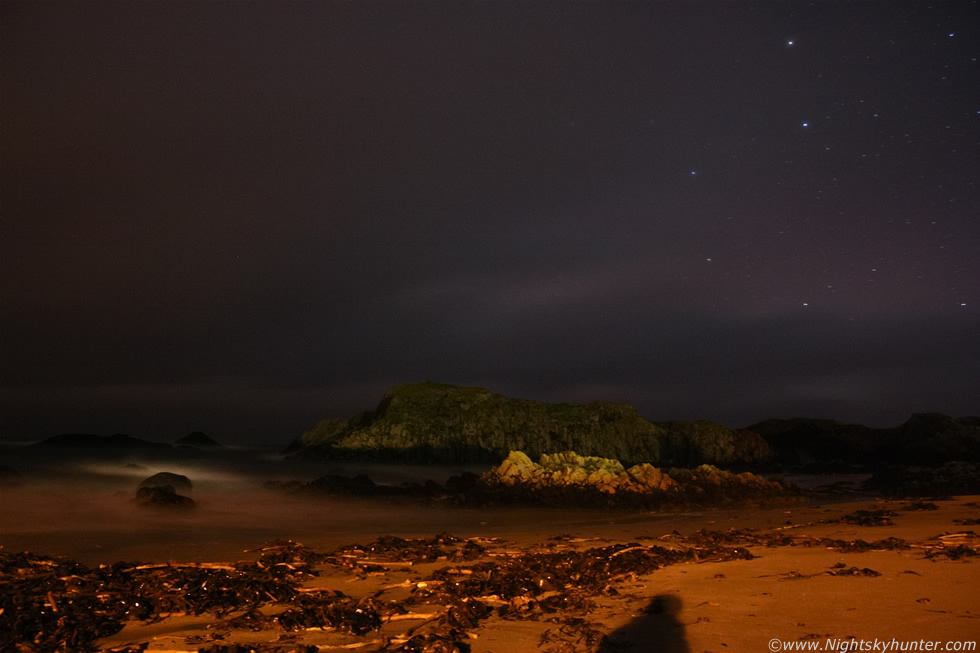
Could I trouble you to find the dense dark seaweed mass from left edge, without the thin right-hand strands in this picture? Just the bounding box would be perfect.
[0,534,751,653]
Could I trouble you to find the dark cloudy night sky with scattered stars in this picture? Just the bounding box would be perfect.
[0,0,980,443]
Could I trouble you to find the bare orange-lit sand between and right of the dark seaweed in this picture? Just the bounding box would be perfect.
[95,497,980,653]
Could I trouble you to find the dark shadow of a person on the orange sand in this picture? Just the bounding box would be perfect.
[598,594,691,653]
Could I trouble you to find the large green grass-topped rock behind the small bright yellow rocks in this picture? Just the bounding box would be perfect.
[288,382,772,466]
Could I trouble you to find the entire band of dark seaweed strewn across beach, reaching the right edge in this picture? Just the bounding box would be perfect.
[0,515,980,653]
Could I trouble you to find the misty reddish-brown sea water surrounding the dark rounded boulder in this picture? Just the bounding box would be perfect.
[0,453,684,564]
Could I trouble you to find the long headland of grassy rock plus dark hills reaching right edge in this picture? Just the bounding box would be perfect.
[287,381,980,468]
